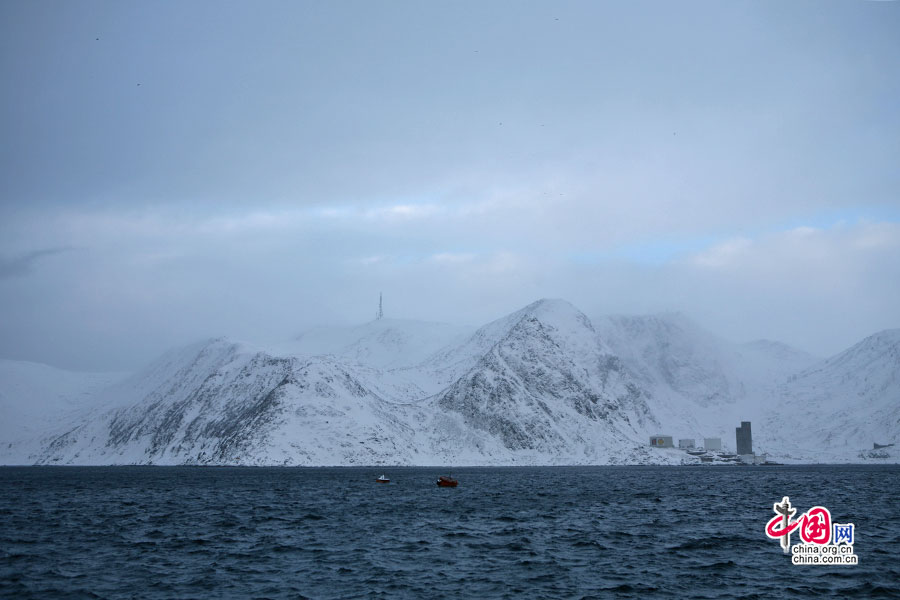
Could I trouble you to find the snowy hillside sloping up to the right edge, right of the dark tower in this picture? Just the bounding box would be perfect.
[760,329,900,462]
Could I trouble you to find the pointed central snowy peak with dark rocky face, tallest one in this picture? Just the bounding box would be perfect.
[433,300,658,463]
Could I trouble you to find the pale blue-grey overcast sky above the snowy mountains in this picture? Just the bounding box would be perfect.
[0,0,900,370]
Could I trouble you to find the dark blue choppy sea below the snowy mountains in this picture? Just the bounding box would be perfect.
[0,466,900,598]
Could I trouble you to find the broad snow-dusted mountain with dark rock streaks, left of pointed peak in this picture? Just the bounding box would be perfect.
[35,339,428,464]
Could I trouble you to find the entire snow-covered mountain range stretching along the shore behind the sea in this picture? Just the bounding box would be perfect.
[0,300,900,465]
